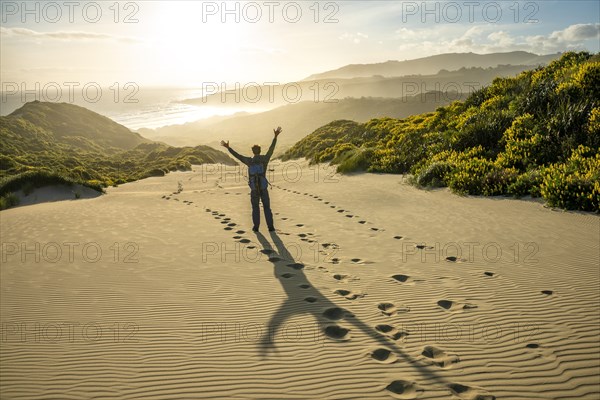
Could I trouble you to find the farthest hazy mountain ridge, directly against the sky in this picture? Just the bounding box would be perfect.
[303,51,561,81]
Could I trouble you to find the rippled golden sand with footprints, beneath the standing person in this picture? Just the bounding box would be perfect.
[0,163,600,399]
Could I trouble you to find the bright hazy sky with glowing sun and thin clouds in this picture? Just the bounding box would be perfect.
[0,0,600,87]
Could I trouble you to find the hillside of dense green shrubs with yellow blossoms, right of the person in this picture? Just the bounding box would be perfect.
[283,52,600,211]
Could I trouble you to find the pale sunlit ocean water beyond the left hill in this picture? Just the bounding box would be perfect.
[0,87,249,130]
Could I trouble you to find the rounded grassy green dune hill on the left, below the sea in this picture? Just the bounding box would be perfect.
[0,102,235,209]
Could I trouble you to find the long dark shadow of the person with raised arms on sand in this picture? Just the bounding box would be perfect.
[256,232,449,386]
